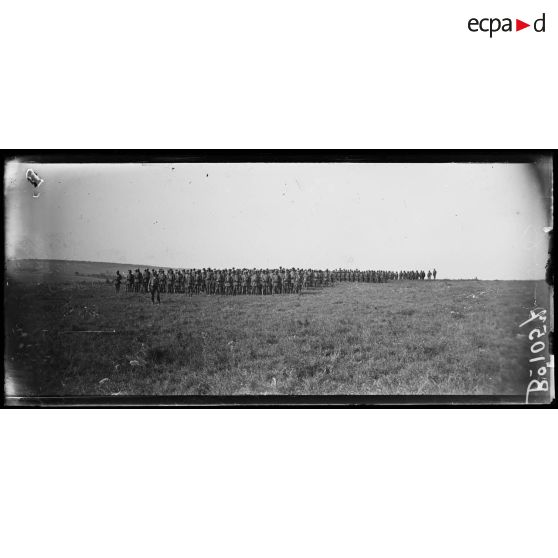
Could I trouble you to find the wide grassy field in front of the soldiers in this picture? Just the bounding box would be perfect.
[5,274,546,396]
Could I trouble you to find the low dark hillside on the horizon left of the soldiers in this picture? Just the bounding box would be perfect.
[5,260,151,283]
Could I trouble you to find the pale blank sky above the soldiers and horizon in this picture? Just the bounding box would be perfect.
[5,161,548,279]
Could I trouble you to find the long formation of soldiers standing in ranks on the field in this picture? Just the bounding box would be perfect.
[114,267,437,302]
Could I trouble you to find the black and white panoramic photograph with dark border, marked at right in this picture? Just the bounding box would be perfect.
[4,152,554,405]
